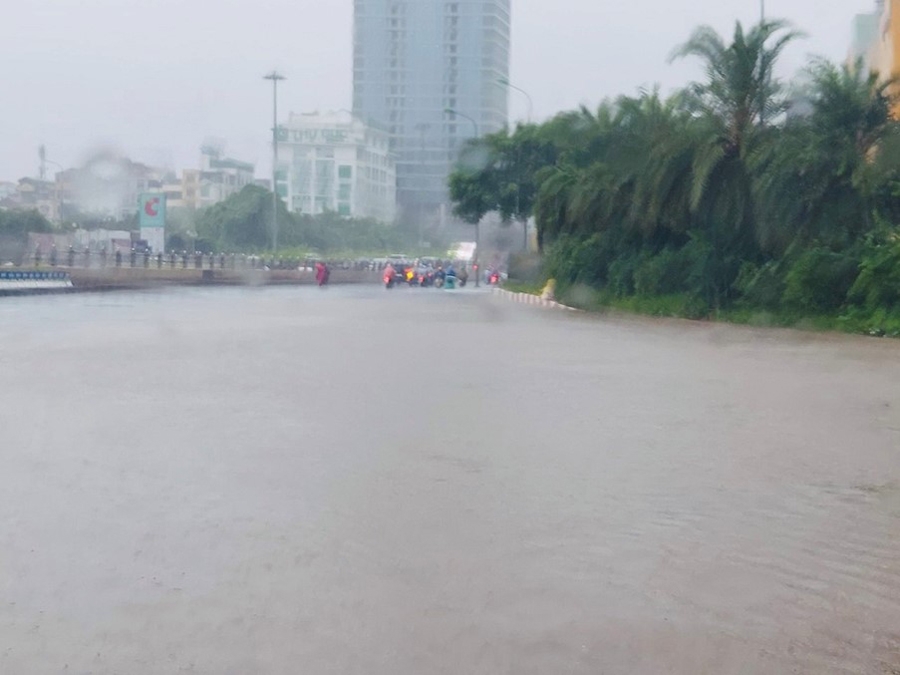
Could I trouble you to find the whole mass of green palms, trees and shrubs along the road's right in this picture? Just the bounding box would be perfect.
[450,21,900,335]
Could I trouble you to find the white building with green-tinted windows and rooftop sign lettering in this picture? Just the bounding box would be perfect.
[276,111,397,222]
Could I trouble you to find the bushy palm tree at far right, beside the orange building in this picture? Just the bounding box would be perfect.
[754,60,900,255]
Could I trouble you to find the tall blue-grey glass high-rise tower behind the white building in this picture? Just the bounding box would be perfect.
[353,0,510,224]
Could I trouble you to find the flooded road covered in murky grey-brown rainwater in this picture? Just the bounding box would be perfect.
[0,288,900,675]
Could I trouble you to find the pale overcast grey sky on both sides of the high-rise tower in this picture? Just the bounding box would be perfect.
[0,0,874,180]
